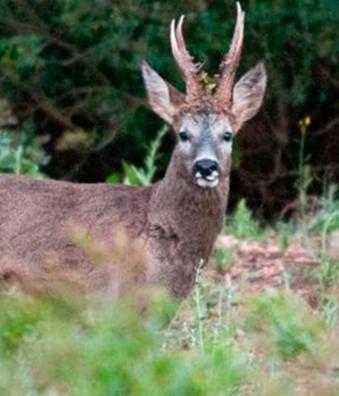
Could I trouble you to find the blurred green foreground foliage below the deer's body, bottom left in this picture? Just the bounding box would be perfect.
[0,295,251,395]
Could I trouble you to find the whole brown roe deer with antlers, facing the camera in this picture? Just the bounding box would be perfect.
[0,3,266,297]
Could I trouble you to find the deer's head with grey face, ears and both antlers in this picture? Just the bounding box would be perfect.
[142,3,266,188]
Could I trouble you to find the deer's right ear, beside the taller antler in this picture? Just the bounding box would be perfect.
[232,63,267,130]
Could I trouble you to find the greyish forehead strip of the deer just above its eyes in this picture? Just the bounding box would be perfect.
[178,113,232,136]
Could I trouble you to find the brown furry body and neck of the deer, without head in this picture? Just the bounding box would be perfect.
[0,148,228,297]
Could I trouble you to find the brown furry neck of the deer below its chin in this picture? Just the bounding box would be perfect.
[150,147,229,255]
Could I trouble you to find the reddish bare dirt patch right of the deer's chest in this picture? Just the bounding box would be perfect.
[216,235,318,307]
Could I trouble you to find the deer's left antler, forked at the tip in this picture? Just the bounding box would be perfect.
[170,15,204,102]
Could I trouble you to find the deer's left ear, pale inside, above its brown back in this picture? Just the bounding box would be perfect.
[142,61,184,124]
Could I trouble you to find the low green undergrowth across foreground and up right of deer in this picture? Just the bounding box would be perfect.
[0,200,339,396]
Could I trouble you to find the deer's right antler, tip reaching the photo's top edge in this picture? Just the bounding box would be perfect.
[215,2,245,106]
